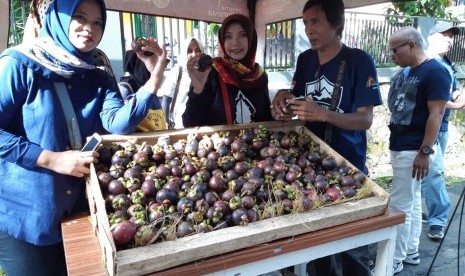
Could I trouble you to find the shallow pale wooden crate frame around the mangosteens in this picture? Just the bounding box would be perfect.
[87,122,389,275]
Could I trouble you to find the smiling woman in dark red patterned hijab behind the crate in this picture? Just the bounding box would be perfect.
[183,14,273,127]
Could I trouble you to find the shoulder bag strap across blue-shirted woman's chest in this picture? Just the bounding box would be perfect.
[53,82,82,150]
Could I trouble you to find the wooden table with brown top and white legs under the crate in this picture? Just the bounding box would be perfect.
[62,209,405,276]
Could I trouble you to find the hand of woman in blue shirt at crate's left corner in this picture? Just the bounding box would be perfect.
[36,150,99,177]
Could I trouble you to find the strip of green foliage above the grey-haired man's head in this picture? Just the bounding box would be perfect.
[387,0,453,19]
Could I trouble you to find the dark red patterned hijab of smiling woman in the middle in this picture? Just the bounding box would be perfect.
[213,14,266,89]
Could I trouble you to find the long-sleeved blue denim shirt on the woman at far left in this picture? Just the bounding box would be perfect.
[0,48,156,245]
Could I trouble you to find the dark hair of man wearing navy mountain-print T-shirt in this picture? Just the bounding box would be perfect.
[302,0,345,36]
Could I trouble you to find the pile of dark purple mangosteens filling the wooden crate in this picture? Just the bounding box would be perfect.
[96,125,371,249]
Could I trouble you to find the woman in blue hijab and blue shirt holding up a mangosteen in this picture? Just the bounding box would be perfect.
[0,0,166,275]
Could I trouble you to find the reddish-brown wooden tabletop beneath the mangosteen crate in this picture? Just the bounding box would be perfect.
[62,209,405,276]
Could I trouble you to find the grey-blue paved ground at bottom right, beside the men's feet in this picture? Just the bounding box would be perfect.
[396,183,465,276]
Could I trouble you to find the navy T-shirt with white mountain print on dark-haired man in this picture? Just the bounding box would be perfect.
[292,45,382,172]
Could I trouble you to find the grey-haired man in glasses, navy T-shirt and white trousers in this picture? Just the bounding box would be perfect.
[388,27,452,274]
